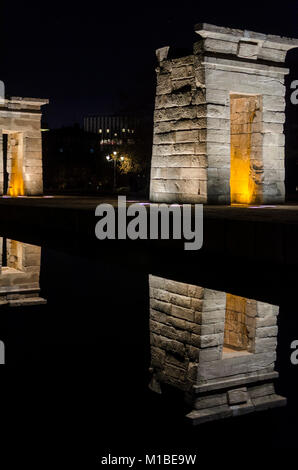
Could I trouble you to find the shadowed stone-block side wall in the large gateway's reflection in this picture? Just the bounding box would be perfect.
[149,275,204,391]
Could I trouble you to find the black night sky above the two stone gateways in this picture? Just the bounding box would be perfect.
[0,0,298,128]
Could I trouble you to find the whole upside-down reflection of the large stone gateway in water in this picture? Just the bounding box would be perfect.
[149,275,286,424]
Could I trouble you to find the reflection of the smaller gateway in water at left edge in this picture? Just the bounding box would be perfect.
[0,237,46,307]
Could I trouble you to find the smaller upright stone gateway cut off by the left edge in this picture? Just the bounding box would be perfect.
[0,97,49,196]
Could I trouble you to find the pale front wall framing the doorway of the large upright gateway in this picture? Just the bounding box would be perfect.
[204,54,285,203]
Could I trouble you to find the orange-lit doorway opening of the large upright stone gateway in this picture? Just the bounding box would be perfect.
[230,94,263,204]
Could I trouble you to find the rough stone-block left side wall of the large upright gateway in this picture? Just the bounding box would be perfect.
[150,53,207,203]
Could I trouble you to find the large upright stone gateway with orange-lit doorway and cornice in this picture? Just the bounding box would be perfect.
[150,23,298,204]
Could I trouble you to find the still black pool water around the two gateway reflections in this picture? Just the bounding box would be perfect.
[0,237,298,469]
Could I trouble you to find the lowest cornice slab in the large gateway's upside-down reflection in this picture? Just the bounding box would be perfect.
[186,394,287,426]
